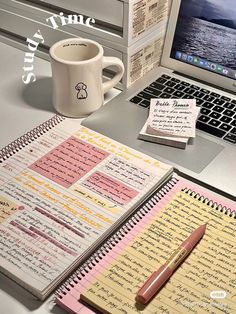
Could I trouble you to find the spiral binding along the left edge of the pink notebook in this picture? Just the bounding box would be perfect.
[55,177,179,299]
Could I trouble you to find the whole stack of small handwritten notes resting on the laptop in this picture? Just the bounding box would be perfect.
[139,99,199,148]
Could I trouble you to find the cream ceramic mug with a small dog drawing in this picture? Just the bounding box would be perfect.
[49,38,124,118]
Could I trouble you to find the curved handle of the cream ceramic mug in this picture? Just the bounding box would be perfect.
[102,57,124,94]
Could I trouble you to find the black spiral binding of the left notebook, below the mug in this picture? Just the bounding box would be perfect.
[0,115,65,163]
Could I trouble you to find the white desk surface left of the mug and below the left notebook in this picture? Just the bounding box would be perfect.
[0,42,119,314]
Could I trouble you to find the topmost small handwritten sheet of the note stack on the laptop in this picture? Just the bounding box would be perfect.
[147,99,196,137]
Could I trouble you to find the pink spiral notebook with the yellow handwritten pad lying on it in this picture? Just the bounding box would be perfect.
[57,177,236,314]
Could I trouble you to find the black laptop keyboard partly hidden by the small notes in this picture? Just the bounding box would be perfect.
[130,74,236,144]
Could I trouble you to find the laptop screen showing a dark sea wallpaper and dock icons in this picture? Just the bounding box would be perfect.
[171,0,236,80]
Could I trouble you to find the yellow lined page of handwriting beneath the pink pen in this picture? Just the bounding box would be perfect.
[82,184,236,314]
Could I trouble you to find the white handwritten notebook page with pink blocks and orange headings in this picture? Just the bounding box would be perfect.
[0,119,171,298]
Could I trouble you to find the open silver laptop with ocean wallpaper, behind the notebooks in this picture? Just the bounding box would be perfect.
[82,0,236,196]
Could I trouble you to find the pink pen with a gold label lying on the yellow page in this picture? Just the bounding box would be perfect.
[136,224,206,304]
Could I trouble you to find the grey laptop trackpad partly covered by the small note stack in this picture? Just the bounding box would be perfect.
[137,136,224,173]
